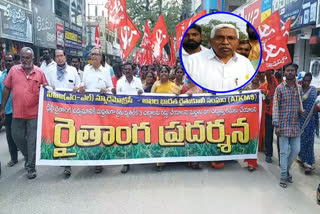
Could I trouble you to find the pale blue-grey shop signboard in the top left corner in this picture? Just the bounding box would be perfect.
[0,1,33,43]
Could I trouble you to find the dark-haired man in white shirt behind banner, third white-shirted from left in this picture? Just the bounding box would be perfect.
[117,63,144,173]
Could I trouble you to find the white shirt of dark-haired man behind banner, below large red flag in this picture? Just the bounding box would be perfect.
[117,76,143,95]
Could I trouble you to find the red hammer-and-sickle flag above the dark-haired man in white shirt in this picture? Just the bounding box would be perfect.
[118,16,141,58]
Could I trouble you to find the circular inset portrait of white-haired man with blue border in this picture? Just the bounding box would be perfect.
[180,12,262,93]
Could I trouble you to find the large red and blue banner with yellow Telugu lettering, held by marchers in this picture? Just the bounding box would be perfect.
[37,88,261,166]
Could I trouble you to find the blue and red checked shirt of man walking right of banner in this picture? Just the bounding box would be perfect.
[272,82,302,137]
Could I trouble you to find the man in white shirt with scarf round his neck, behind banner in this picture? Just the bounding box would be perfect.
[46,49,81,90]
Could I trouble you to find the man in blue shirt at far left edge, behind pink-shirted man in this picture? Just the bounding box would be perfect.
[0,54,18,167]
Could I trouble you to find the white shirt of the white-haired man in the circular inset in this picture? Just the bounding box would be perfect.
[185,49,255,92]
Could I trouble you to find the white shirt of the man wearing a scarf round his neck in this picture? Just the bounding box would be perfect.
[46,64,81,89]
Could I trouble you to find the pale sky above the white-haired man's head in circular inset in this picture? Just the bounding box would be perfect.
[197,13,247,35]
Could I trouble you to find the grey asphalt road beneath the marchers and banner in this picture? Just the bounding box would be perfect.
[0,129,320,214]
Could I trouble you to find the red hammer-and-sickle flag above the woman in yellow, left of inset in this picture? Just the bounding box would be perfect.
[150,14,169,57]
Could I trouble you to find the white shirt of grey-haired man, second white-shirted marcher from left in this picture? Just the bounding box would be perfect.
[82,65,113,89]
